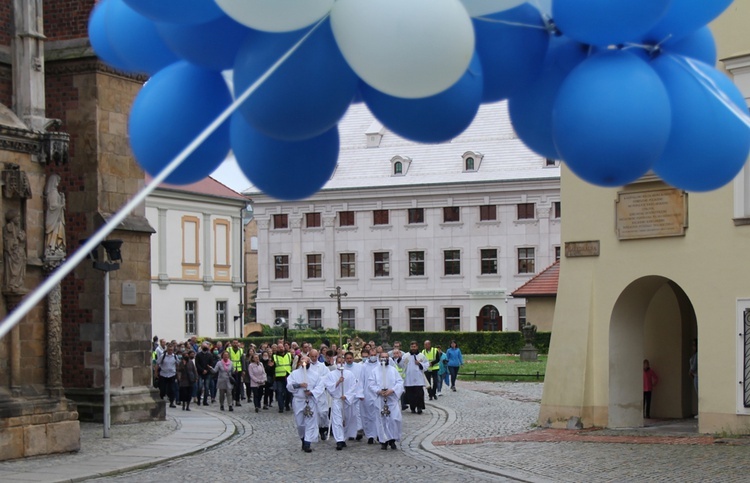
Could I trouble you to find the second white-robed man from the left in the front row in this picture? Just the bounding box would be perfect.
[325,356,359,451]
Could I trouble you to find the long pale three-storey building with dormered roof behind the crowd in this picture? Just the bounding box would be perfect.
[250,103,561,331]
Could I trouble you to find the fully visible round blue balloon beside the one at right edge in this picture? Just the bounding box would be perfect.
[552,50,671,186]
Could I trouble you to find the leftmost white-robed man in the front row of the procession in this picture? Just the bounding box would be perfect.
[286,357,325,453]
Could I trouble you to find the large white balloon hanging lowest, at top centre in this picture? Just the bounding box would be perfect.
[331,0,474,99]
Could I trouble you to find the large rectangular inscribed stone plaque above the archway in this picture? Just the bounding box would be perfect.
[615,188,687,240]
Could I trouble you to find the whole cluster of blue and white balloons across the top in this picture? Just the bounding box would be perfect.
[89,0,750,199]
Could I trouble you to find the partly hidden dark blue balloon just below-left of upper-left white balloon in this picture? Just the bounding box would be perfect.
[156,15,253,70]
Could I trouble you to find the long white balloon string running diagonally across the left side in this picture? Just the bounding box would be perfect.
[0,15,328,339]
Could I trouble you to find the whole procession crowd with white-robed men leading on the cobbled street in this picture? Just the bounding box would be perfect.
[152,337,463,453]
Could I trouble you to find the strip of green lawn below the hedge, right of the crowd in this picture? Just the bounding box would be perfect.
[459,354,547,382]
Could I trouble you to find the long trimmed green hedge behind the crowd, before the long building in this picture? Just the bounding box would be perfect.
[212,328,552,354]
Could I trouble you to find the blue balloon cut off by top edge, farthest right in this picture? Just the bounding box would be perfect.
[646,0,732,43]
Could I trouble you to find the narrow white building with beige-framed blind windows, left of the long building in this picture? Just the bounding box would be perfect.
[146,178,247,341]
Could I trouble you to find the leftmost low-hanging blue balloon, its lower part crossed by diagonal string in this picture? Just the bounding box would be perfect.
[128,61,232,184]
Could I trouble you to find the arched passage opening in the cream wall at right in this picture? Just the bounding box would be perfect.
[607,276,697,428]
